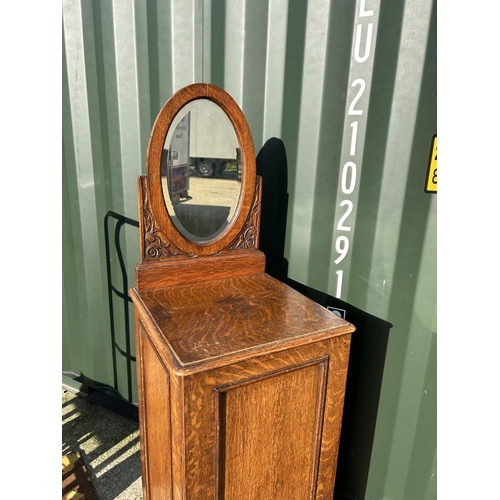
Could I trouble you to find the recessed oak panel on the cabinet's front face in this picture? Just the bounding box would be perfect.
[219,363,326,500]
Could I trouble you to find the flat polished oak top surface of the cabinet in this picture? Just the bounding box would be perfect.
[132,273,354,373]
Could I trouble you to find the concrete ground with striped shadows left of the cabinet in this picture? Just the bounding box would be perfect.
[62,388,143,500]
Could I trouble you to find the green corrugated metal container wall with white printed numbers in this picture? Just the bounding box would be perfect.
[62,0,437,500]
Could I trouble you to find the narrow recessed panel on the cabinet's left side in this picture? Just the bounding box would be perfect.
[139,326,172,500]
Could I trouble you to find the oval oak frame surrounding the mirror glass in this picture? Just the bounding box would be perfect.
[146,83,256,255]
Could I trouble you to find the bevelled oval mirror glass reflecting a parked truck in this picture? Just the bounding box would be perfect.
[161,99,242,242]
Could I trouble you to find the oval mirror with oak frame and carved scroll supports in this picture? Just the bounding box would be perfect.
[140,83,260,258]
